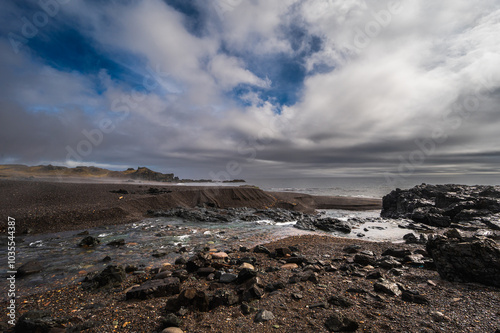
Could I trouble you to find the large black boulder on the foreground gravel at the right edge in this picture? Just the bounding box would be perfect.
[426,236,500,288]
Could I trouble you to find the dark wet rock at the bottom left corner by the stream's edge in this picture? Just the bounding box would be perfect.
[14,310,69,333]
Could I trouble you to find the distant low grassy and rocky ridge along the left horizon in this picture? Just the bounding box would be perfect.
[0,164,245,183]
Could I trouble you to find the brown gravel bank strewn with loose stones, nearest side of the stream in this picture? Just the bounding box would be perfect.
[11,233,500,333]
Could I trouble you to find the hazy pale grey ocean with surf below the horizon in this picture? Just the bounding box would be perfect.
[247,175,500,198]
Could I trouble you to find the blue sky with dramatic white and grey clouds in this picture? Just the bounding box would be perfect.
[0,0,500,178]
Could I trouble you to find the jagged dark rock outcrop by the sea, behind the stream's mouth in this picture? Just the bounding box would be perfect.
[381,184,500,230]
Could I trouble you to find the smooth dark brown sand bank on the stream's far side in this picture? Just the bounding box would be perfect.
[0,179,381,233]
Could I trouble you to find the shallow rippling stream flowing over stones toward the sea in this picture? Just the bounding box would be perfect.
[0,210,408,299]
